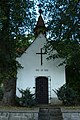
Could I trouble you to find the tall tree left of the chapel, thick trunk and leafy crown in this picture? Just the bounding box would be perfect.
[0,0,35,105]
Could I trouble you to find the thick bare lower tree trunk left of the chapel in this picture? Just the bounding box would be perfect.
[2,79,16,106]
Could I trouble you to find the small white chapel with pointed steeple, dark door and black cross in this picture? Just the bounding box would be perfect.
[16,10,66,104]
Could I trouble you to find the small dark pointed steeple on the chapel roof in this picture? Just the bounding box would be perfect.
[34,9,46,37]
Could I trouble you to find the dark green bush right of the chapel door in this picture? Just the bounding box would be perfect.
[53,84,79,105]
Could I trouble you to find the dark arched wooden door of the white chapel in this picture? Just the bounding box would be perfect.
[36,76,48,104]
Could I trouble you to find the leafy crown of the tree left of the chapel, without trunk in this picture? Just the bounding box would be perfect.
[0,0,35,81]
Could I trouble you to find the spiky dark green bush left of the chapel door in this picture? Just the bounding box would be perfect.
[17,88,35,107]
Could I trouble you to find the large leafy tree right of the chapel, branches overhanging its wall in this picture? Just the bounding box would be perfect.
[39,0,80,94]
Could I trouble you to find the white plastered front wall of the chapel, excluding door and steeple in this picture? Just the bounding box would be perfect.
[17,34,65,98]
